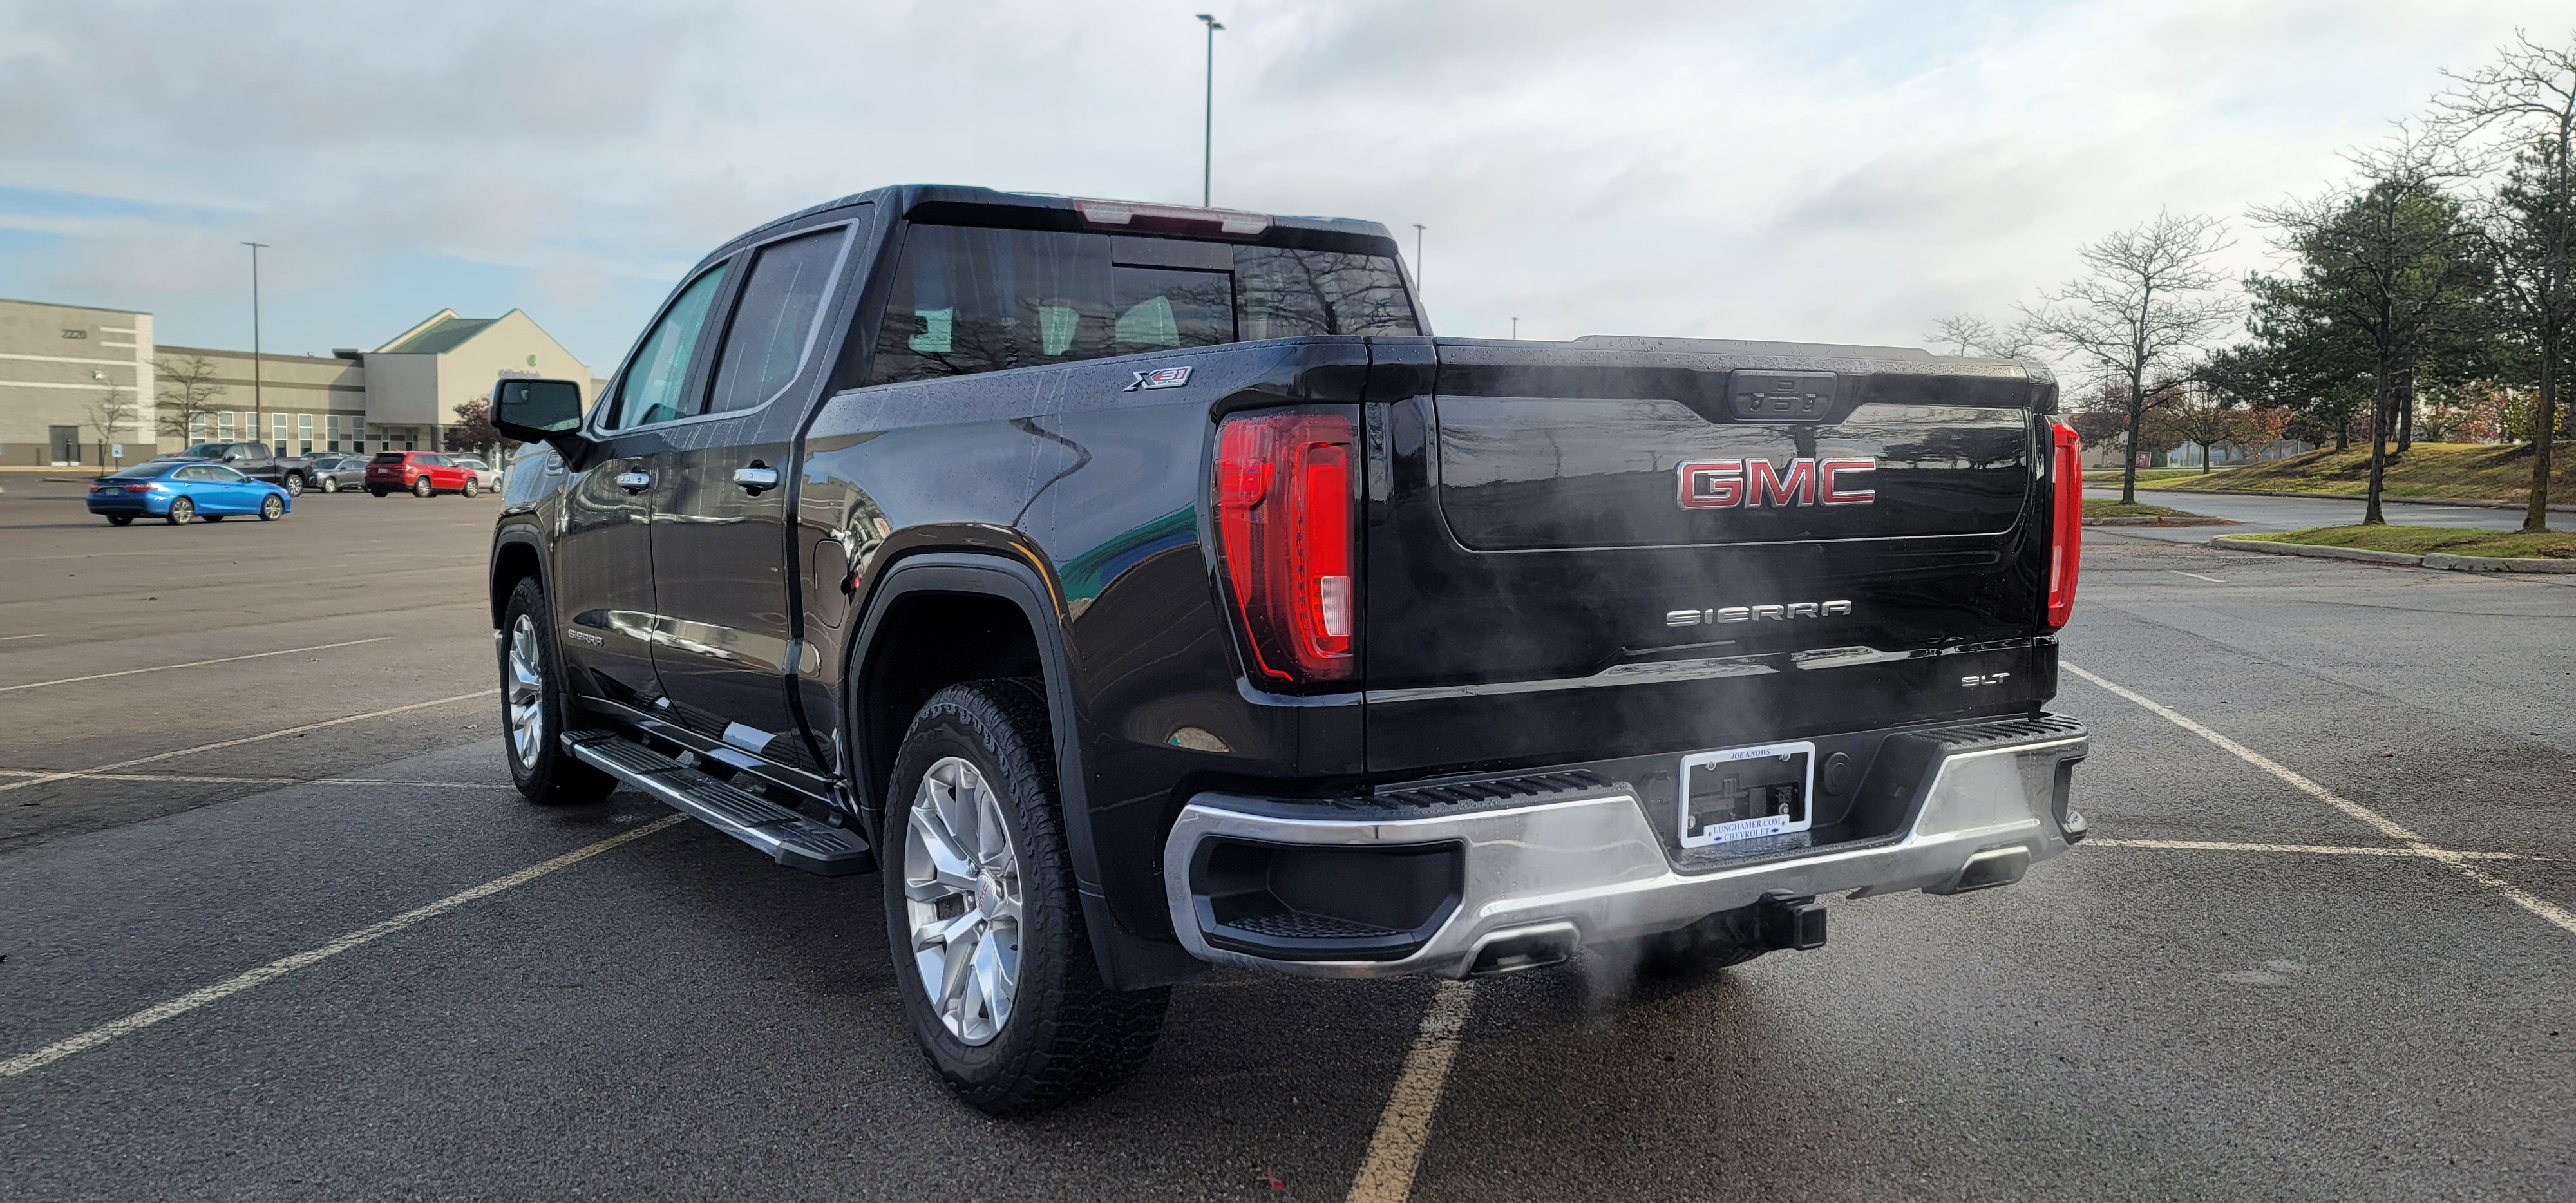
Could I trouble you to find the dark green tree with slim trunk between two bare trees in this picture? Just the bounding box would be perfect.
[2254,129,2486,526]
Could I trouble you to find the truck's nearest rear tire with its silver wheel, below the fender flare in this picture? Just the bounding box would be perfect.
[878,680,1172,1115]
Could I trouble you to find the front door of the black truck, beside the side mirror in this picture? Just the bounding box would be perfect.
[551,263,732,706]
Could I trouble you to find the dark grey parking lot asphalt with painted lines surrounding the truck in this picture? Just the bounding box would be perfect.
[0,484,2576,1200]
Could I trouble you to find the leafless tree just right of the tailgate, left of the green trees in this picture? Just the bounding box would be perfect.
[2022,209,2239,505]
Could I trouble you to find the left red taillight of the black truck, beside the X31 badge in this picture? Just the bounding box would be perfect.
[1216,410,1360,683]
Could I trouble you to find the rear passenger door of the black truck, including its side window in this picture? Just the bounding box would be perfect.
[652,219,855,768]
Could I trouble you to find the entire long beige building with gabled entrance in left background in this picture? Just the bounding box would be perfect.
[0,301,598,469]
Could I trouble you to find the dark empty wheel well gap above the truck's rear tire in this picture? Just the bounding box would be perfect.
[855,590,1046,811]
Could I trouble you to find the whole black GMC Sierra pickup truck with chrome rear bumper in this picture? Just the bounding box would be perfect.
[489,185,2087,1113]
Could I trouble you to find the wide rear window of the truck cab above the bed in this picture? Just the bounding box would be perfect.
[868,224,1419,384]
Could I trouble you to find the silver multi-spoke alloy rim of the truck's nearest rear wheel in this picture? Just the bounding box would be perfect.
[904,757,1020,1043]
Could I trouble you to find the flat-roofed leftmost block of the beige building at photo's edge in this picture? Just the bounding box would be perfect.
[0,301,157,466]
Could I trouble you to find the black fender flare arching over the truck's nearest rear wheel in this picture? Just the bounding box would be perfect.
[840,551,1133,987]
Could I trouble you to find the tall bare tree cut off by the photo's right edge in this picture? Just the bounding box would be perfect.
[2434,28,2576,531]
